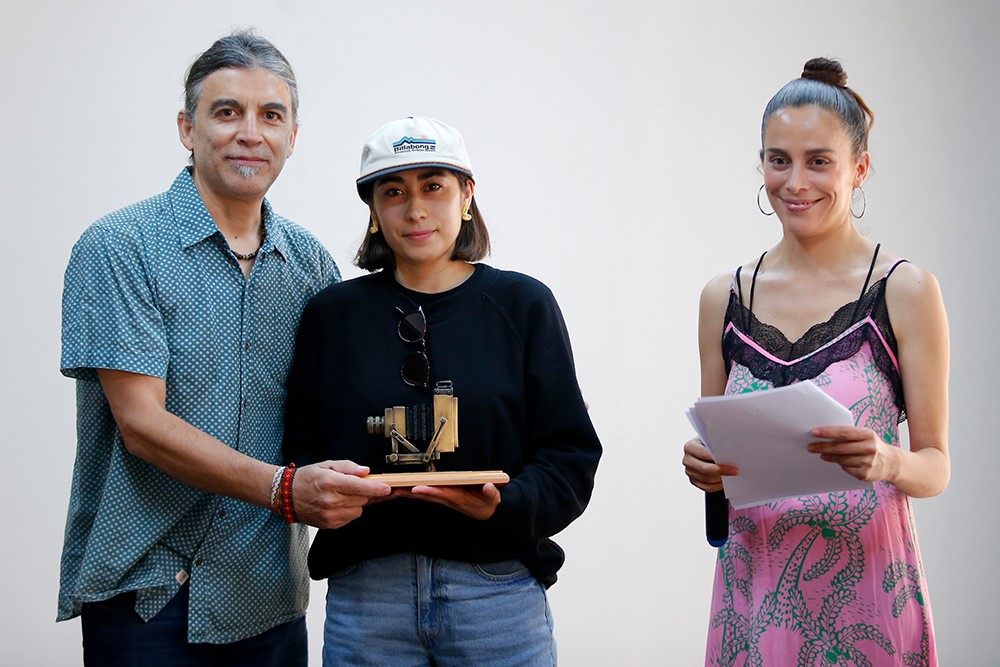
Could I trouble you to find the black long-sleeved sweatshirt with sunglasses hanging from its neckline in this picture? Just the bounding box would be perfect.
[284,264,601,586]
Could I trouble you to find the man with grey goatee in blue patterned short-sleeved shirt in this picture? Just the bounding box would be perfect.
[58,32,390,667]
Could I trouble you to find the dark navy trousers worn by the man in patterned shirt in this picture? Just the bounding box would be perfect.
[81,585,308,667]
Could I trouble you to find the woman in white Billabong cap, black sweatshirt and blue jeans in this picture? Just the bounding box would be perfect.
[285,118,601,665]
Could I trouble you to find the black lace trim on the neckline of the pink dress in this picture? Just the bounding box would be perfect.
[722,260,906,422]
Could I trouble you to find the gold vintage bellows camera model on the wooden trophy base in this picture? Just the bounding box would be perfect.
[368,380,458,472]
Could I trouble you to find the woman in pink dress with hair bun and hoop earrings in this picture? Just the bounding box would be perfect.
[684,59,950,665]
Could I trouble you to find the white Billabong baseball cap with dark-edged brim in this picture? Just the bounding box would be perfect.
[358,116,473,192]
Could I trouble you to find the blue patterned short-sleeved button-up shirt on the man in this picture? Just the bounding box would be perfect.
[58,169,340,643]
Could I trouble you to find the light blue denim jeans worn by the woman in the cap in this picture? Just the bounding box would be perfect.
[323,553,556,667]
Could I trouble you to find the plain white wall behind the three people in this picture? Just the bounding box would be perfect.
[0,0,1000,666]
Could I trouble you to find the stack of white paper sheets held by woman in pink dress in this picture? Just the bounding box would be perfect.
[687,381,872,508]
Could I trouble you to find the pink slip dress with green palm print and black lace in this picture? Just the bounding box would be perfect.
[705,246,937,667]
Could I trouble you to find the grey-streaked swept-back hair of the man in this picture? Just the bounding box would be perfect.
[184,31,299,125]
